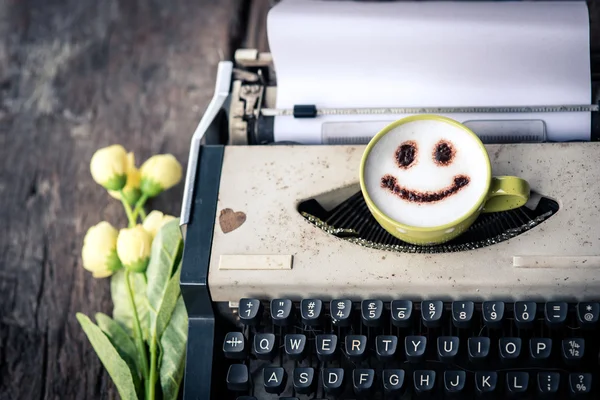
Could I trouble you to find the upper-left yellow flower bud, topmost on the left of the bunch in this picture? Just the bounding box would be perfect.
[90,144,127,190]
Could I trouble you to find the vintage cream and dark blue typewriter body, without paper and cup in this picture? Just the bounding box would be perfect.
[181,1,600,400]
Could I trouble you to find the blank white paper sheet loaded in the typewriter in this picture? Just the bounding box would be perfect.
[267,0,591,144]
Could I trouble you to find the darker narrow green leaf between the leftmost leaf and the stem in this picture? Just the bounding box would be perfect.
[96,313,144,397]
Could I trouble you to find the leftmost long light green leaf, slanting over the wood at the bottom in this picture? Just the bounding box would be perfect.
[77,313,138,400]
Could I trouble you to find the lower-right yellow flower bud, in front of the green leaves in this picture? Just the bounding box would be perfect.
[117,225,152,272]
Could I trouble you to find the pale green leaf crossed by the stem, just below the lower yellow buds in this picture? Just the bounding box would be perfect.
[110,269,150,340]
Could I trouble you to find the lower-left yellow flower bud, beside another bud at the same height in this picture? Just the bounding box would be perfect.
[81,221,121,278]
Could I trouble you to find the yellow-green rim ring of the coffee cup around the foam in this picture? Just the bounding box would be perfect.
[359,114,492,233]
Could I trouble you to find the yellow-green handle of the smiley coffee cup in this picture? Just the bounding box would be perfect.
[481,176,530,213]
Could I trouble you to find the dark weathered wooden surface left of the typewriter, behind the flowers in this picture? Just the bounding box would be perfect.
[0,0,244,400]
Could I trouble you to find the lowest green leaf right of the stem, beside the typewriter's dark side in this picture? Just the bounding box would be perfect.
[160,296,188,400]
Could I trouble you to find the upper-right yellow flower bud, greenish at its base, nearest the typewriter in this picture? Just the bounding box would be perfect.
[140,154,182,197]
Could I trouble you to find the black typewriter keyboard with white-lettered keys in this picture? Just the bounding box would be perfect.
[222,298,600,400]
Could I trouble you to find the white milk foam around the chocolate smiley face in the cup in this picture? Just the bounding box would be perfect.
[364,120,489,227]
